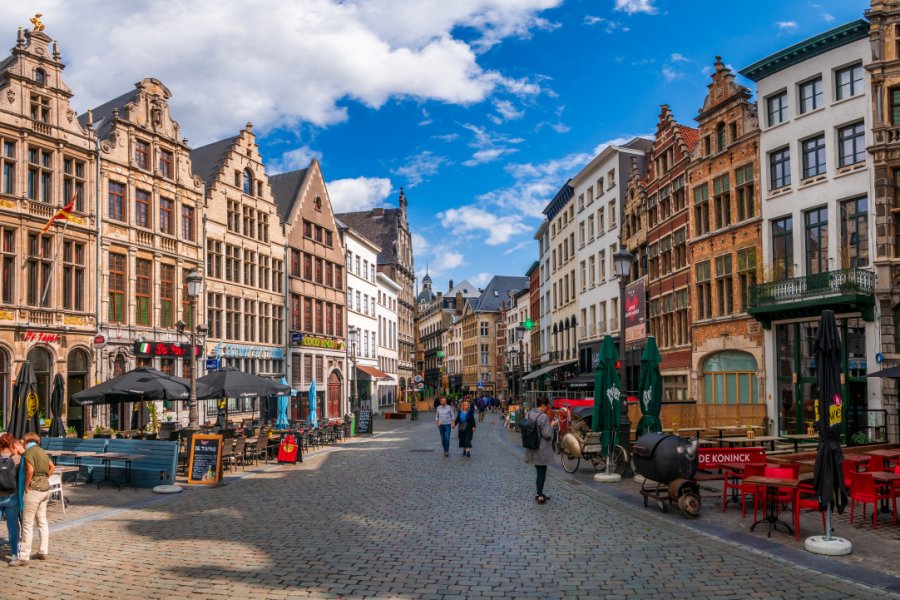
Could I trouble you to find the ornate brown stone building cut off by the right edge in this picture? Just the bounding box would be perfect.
[866,0,900,441]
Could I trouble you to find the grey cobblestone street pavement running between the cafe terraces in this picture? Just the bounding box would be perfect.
[0,417,888,600]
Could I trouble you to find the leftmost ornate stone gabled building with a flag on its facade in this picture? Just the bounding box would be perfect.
[0,23,100,433]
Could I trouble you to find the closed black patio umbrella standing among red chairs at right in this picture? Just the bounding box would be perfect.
[813,310,847,540]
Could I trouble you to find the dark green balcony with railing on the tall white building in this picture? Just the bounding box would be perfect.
[747,267,875,329]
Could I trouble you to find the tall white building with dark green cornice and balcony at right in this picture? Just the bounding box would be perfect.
[741,20,881,437]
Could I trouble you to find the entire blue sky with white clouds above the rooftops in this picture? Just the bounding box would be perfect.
[0,0,868,289]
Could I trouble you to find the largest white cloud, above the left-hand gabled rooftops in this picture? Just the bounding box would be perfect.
[0,0,562,145]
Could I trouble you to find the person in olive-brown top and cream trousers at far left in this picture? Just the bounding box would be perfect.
[9,432,56,567]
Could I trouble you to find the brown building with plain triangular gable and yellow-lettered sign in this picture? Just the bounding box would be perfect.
[269,159,349,420]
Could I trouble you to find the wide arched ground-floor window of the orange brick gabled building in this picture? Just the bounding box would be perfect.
[703,350,759,404]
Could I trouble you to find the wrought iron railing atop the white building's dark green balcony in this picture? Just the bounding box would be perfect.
[750,267,875,307]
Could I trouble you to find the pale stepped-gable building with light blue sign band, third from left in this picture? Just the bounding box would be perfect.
[191,123,287,419]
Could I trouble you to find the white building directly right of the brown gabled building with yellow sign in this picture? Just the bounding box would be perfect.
[339,223,386,409]
